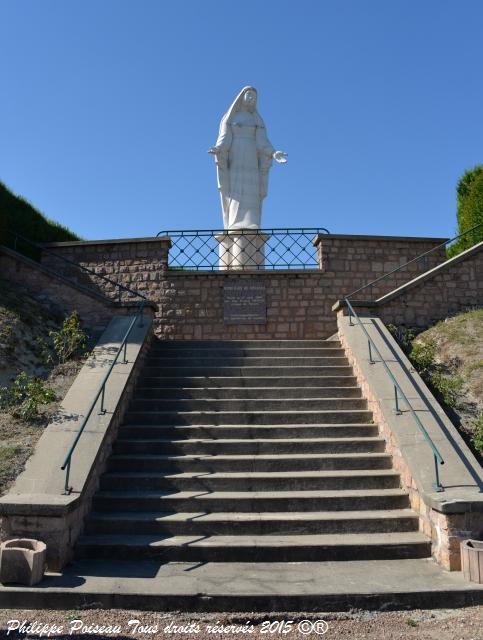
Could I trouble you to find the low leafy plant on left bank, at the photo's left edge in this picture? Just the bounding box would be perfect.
[0,371,55,422]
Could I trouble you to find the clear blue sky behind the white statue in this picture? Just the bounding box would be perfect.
[0,0,483,239]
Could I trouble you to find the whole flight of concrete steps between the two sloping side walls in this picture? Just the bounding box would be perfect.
[77,340,431,563]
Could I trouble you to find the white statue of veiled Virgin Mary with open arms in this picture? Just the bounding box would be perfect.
[208,87,287,229]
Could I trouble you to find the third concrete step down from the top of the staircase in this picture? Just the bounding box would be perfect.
[145,353,349,370]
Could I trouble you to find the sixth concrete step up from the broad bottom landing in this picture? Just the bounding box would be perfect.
[114,437,385,455]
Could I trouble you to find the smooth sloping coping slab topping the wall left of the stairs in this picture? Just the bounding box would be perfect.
[0,316,152,516]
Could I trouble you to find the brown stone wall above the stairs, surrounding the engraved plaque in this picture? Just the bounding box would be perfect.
[42,235,445,339]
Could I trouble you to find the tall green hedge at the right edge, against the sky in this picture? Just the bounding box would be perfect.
[448,165,483,257]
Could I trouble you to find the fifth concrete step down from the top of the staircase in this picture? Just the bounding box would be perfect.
[138,371,357,393]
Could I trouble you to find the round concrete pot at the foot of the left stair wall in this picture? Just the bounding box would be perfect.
[0,538,47,587]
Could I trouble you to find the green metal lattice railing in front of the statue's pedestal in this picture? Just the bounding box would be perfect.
[157,227,329,271]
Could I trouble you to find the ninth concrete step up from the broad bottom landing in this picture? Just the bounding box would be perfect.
[129,394,367,413]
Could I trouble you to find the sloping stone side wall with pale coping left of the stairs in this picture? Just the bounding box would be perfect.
[0,318,153,571]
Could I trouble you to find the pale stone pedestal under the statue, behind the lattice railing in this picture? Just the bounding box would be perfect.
[215,231,269,271]
